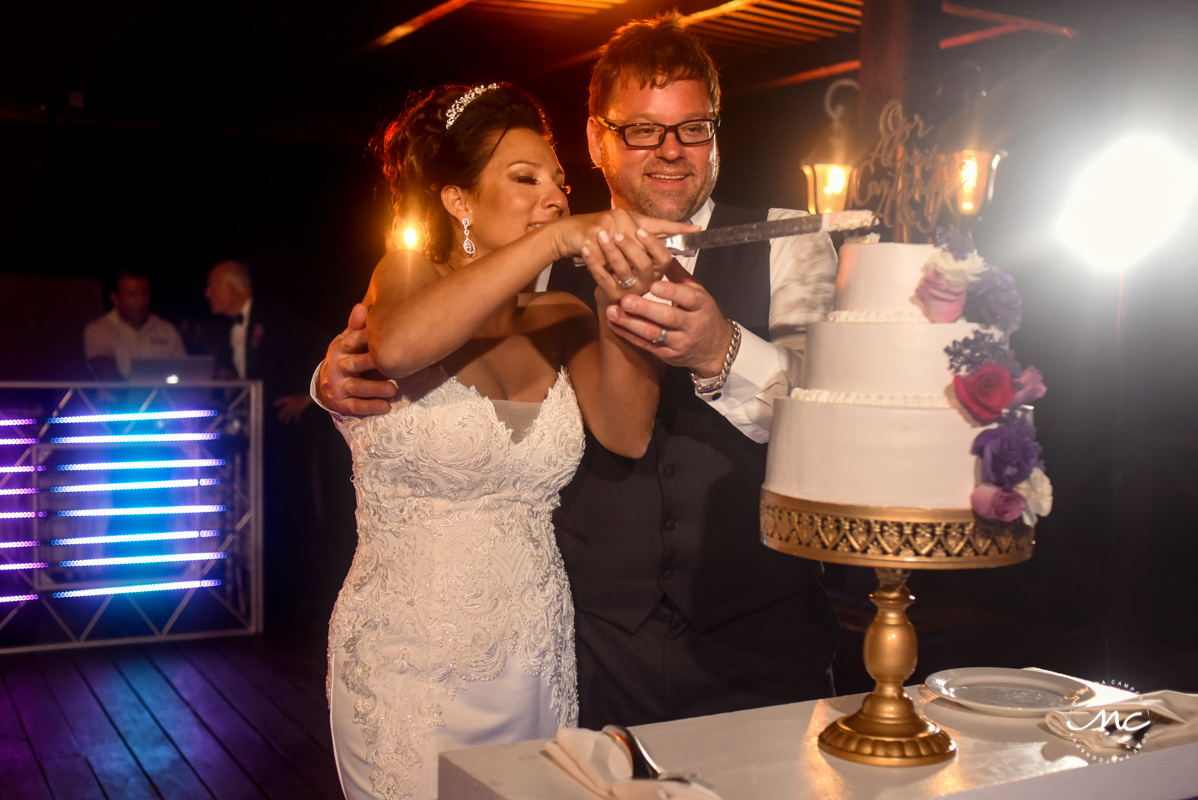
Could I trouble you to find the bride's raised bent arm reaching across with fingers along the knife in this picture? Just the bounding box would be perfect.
[364,211,692,378]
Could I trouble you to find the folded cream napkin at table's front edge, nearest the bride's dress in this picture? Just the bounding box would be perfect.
[545,728,720,800]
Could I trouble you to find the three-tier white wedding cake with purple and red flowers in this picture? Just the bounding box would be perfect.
[764,234,1051,523]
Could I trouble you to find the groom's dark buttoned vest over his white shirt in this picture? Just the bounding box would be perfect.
[549,205,822,631]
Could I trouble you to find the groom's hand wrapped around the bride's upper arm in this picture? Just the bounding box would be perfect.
[316,303,395,417]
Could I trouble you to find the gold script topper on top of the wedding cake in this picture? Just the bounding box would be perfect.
[853,101,954,235]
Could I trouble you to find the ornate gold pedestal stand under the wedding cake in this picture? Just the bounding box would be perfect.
[761,489,1035,766]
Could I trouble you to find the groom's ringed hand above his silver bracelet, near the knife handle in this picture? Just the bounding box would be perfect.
[606,261,732,377]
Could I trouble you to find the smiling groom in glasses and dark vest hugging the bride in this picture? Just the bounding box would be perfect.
[317,13,839,728]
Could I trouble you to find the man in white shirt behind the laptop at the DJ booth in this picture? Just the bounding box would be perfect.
[83,271,187,381]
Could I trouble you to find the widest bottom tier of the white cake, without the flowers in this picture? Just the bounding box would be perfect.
[764,398,982,509]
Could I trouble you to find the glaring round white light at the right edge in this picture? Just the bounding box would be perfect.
[1057,133,1198,271]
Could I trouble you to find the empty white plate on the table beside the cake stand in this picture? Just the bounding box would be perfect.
[925,667,1094,716]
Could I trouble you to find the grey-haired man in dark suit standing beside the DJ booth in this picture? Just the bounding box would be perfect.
[205,261,329,632]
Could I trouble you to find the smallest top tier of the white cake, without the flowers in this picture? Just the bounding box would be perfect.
[828,243,936,322]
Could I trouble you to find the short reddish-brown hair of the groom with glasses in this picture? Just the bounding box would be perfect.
[588,10,720,116]
